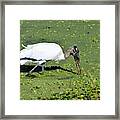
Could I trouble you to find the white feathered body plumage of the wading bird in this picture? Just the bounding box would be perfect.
[20,43,65,65]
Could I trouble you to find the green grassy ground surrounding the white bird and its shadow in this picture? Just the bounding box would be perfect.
[20,20,100,100]
